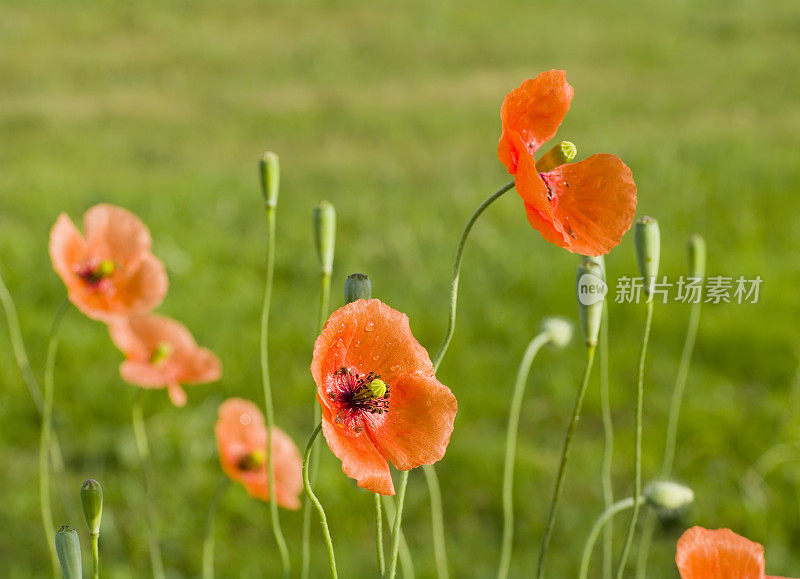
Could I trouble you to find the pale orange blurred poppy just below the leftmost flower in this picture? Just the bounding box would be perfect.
[108,314,222,406]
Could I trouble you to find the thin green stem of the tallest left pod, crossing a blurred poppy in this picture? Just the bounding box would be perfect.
[261,205,291,578]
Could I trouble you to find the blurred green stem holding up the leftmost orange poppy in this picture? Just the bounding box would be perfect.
[39,300,69,575]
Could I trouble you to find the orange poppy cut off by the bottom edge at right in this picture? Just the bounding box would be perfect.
[675,527,786,579]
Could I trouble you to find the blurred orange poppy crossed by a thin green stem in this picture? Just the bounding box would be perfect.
[215,398,303,509]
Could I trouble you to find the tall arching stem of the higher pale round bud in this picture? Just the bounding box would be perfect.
[497,332,550,579]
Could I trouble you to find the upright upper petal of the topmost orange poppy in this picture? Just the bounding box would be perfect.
[497,70,573,173]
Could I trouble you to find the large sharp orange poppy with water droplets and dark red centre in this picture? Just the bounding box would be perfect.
[311,300,456,495]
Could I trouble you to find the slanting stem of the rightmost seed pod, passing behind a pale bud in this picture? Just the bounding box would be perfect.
[636,300,702,579]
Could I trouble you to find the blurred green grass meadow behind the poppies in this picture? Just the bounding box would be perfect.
[0,0,800,578]
